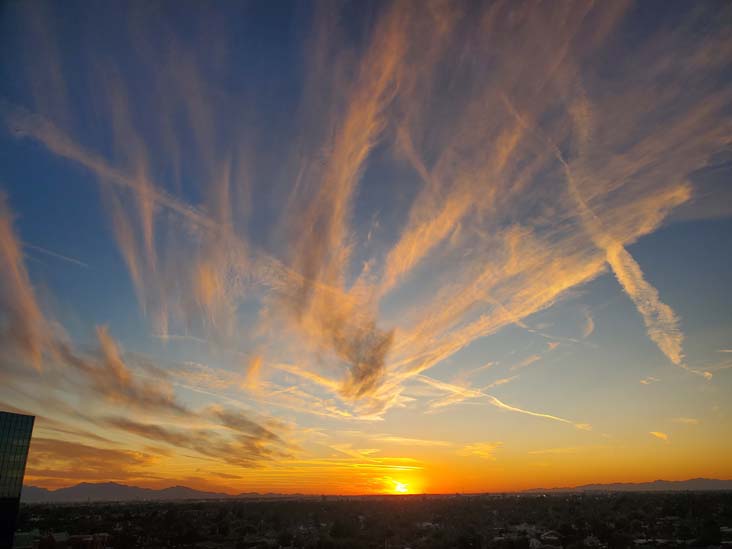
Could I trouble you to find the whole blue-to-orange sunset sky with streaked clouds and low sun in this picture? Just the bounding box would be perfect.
[0,0,732,494]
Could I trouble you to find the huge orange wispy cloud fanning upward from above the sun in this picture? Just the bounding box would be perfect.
[3,4,725,408]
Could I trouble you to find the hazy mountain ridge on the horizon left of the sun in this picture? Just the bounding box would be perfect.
[20,482,293,503]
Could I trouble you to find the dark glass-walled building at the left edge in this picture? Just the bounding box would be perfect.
[0,412,35,549]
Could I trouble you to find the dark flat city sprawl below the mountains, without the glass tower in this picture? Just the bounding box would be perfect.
[10,491,732,549]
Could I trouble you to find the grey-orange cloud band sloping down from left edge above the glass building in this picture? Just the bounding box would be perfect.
[0,194,292,470]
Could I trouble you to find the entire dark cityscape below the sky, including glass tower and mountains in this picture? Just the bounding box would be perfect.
[0,412,732,549]
